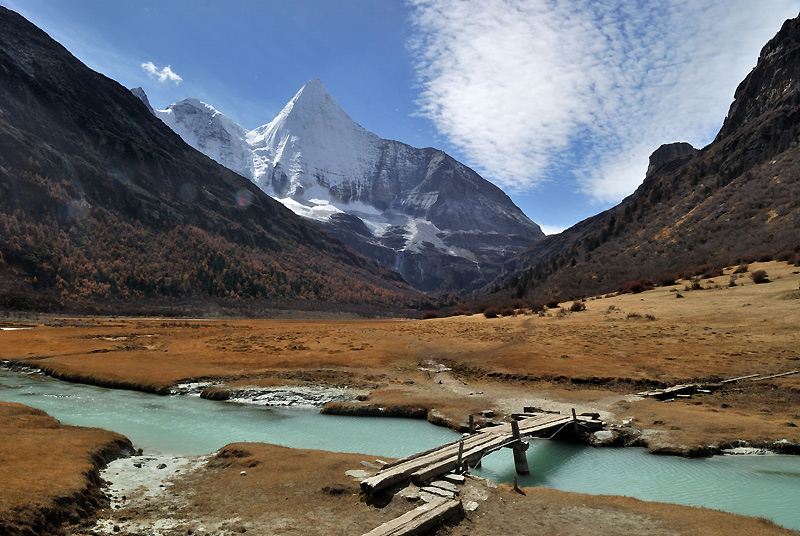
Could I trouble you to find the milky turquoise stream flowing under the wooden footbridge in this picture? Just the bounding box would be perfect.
[0,370,800,529]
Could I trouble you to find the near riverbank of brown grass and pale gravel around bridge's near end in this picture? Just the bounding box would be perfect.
[62,443,797,536]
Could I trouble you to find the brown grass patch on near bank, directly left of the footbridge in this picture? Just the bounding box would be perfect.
[88,443,410,536]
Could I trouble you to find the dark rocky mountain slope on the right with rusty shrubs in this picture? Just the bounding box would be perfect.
[495,15,800,299]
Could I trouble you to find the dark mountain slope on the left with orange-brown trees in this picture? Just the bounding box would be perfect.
[0,8,416,311]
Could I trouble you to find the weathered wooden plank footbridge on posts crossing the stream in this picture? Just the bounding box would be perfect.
[361,410,603,494]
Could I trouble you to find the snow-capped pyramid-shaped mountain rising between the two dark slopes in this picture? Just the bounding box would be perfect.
[134,80,544,291]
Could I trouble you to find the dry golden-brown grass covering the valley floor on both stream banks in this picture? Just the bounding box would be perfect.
[0,263,800,535]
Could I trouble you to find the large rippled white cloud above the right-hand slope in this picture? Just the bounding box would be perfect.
[411,0,800,203]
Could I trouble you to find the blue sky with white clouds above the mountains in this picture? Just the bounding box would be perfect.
[0,0,800,232]
